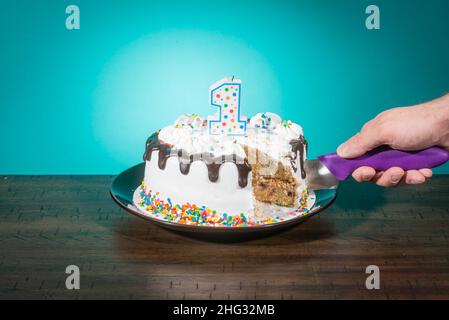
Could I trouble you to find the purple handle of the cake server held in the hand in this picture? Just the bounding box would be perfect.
[318,147,449,181]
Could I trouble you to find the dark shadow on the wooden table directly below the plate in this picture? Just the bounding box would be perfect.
[108,213,334,272]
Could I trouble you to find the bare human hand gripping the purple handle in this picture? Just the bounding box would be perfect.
[337,95,449,187]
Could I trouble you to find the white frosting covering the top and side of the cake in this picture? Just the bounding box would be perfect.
[144,113,306,215]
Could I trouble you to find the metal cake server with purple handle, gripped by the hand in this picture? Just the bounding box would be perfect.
[305,146,449,190]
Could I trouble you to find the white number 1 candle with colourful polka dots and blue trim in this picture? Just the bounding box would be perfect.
[208,78,246,135]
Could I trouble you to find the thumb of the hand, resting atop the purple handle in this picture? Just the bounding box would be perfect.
[337,130,383,158]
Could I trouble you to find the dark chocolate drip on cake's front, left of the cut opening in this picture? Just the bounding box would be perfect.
[143,131,251,188]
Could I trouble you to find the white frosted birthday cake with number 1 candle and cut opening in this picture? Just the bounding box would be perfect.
[134,78,313,227]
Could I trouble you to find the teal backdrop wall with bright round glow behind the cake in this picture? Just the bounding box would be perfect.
[0,0,449,174]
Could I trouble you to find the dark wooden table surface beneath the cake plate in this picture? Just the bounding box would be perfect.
[0,176,449,299]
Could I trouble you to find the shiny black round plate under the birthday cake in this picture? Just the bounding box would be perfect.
[110,163,337,241]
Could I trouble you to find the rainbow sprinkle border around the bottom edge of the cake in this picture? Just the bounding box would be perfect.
[137,183,309,227]
